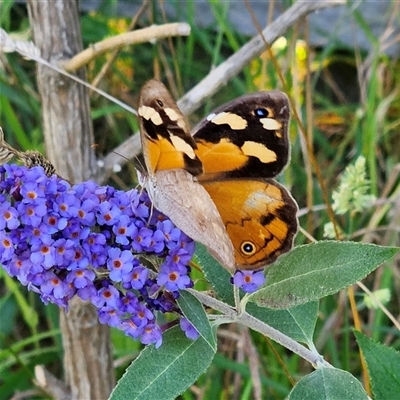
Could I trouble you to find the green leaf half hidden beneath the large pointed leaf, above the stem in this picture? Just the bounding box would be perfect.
[246,301,318,347]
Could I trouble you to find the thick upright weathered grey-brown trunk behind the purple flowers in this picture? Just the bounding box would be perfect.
[28,0,115,400]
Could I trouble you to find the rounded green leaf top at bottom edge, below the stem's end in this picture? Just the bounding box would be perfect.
[288,368,368,400]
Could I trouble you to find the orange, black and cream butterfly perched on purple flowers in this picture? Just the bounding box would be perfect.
[138,79,298,272]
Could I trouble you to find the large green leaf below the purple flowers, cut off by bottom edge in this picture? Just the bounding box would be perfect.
[110,326,216,400]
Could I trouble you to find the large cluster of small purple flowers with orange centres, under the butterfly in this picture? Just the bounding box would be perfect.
[0,164,196,347]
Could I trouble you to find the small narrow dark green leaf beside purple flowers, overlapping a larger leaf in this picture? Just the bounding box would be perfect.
[177,291,217,351]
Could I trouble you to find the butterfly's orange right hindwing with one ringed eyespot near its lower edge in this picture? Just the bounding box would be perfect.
[202,180,297,269]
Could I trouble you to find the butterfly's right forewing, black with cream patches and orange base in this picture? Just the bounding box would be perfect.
[193,91,290,180]
